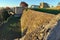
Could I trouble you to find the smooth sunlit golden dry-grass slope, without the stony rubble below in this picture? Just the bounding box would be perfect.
[21,10,55,33]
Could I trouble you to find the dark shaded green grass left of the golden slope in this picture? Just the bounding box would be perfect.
[0,16,21,40]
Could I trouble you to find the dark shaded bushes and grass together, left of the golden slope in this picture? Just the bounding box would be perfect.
[0,9,21,40]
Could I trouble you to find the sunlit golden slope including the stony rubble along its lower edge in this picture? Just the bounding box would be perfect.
[21,10,58,40]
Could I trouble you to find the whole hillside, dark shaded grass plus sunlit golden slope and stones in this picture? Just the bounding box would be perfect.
[0,9,60,40]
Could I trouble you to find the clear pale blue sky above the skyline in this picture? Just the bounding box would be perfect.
[0,0,60,7]
